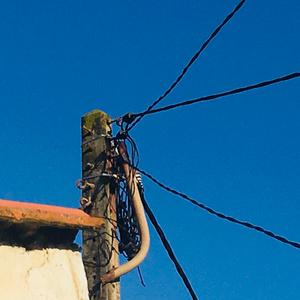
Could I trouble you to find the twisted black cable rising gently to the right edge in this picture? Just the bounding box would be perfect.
[133,72,300,118]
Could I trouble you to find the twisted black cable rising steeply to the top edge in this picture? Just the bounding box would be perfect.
[127,0,245,131]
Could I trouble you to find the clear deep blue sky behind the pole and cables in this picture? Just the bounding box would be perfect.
[0,0,300,300]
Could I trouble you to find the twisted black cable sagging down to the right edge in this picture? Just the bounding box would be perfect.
[135,168,300,249]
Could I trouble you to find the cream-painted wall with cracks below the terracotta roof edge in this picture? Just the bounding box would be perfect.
[0,246,89,300]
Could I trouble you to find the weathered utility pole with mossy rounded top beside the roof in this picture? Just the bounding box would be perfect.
[79,110,120,300]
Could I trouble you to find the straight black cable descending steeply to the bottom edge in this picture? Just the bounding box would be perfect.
[140,191,198,300]
